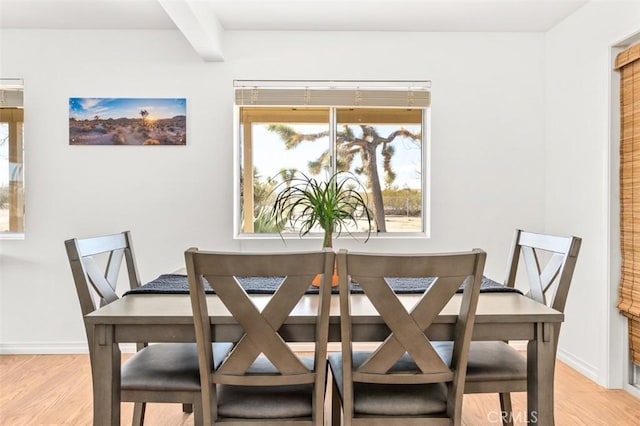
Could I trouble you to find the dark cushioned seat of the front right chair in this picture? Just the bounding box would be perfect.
[329,352,447,416]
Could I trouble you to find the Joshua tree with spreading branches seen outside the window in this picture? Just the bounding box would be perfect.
[268,124,421,232]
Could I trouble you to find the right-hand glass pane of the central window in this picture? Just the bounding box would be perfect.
[336,108,423,232]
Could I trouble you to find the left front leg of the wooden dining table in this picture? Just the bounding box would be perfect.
[93,325,120,426]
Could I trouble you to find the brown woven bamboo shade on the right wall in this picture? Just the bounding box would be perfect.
[616,44,640,365]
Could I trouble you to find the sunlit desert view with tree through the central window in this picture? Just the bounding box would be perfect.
[245,109,424,233]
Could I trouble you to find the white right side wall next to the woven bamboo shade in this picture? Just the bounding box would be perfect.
[544,1,640,387]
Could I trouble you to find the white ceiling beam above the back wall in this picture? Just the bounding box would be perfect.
[158,0,224,62]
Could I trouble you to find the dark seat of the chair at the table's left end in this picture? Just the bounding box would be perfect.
[121,343,233,392]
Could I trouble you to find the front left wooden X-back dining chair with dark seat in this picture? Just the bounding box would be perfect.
[185,248,335,426]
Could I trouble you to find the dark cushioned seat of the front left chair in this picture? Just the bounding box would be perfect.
[217,355,314,419]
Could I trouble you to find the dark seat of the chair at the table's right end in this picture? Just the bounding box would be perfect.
[434,341,527,383]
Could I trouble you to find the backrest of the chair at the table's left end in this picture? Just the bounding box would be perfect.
[64,231,140,354]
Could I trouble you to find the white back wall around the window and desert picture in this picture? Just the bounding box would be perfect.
[0,30,544,353]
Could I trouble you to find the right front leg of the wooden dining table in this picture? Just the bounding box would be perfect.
[527,323,555,426]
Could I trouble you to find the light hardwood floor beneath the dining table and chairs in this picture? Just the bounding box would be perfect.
[0,355,640,426]
